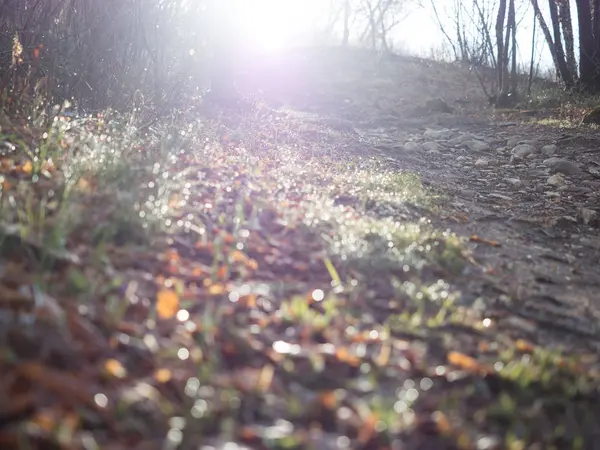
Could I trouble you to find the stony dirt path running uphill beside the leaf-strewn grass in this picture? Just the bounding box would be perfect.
[250,49,600,350]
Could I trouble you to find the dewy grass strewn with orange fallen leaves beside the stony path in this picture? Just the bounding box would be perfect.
[0,96,599,449]
